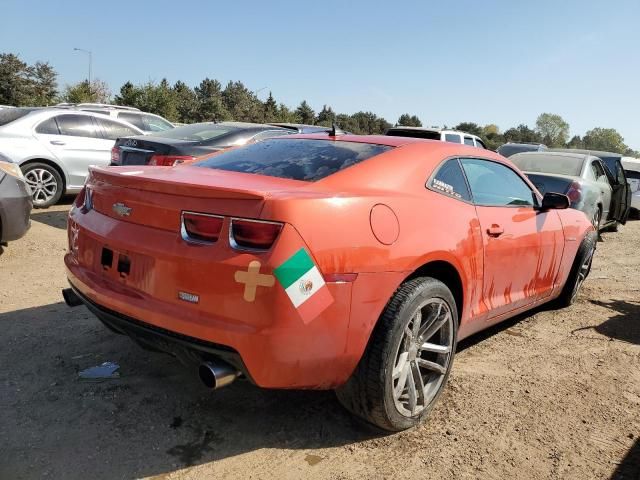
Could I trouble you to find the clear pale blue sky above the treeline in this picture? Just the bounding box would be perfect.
[0,0,640,149]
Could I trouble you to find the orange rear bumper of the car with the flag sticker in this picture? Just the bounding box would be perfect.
[65,209,361,389]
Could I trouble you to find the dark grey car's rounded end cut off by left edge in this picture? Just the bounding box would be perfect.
[0,155,32,246]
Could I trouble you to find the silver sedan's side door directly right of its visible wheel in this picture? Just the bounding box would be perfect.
[35,113,106,189]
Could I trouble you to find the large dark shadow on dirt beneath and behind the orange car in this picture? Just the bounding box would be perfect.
[0,303,381,479]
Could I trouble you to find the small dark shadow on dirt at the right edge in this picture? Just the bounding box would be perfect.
[574,300,640,345]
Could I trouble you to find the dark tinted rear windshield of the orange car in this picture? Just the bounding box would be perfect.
[195,139,393,182]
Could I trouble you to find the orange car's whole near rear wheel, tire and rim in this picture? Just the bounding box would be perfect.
[336,277,458,431]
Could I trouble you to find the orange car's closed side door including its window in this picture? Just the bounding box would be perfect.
[461,158,562,320]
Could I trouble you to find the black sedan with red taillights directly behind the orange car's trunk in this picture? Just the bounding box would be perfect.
[111,122,295,166]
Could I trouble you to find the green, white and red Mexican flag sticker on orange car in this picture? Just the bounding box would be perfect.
[273,248,333,323]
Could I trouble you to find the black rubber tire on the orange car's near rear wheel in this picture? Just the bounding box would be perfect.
[336,277,458,432]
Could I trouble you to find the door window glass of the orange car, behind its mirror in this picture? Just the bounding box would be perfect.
[461,158,537,207]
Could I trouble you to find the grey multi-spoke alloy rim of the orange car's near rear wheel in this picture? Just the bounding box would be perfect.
[391,298,454,417]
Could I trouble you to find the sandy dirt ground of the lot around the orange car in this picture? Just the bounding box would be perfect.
[0,202,640,480]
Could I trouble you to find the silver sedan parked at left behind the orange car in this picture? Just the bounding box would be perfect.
[0,108,142,208]
